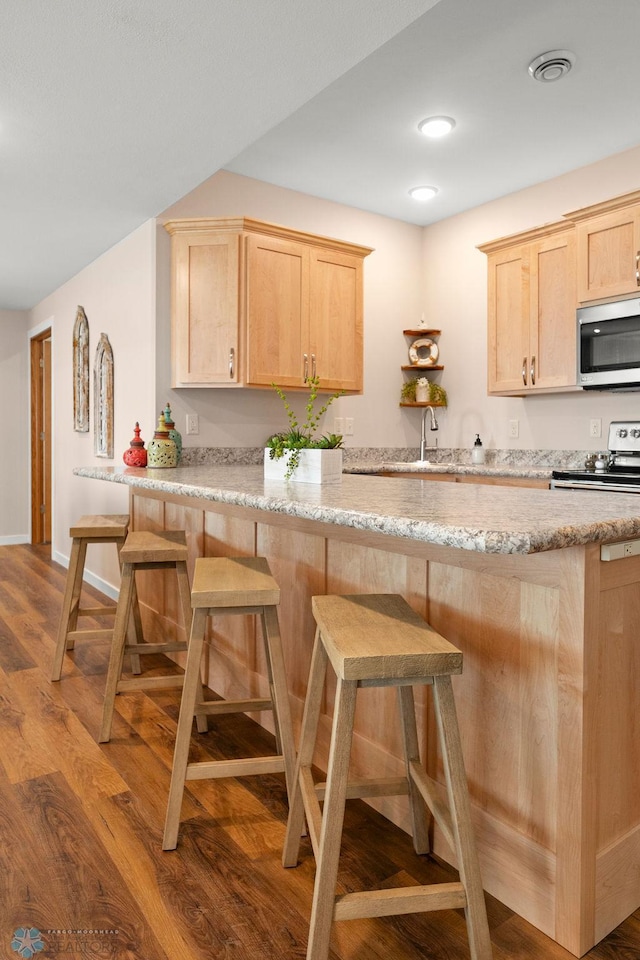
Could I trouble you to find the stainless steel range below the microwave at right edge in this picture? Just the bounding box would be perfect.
[551,420,640,493]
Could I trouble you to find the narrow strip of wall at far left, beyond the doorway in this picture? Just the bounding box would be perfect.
[0,310,31,544]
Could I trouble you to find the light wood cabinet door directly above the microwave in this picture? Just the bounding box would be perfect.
[576,205,640,303]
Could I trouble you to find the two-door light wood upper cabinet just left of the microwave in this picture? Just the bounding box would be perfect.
[478,222,576,396]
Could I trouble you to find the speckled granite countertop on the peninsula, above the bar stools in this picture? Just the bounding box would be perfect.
[73,464,640,554]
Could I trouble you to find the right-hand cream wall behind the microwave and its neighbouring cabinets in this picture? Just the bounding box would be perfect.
[423,147,640,450]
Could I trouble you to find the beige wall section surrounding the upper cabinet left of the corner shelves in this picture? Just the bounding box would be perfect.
[156,171,422,447]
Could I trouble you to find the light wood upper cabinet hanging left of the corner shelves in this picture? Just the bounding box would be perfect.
[165,217,372,393]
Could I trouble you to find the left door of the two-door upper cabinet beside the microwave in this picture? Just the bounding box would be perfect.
[488,247,529,394]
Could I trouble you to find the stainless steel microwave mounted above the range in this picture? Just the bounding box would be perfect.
[578,297,640,391]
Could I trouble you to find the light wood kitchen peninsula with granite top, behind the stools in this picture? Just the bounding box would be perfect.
[74,465,640,956]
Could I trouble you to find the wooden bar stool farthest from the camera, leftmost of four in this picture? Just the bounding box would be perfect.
[51,514,142,680]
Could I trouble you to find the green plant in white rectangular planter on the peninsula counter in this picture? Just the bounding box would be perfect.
[264,377,344,483]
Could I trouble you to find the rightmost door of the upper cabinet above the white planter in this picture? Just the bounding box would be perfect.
[309,248,363,392]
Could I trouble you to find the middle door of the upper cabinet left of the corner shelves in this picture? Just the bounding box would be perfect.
[245,235,311,387]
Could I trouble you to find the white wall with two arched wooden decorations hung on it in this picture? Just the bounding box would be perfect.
[30,221,156,592]
